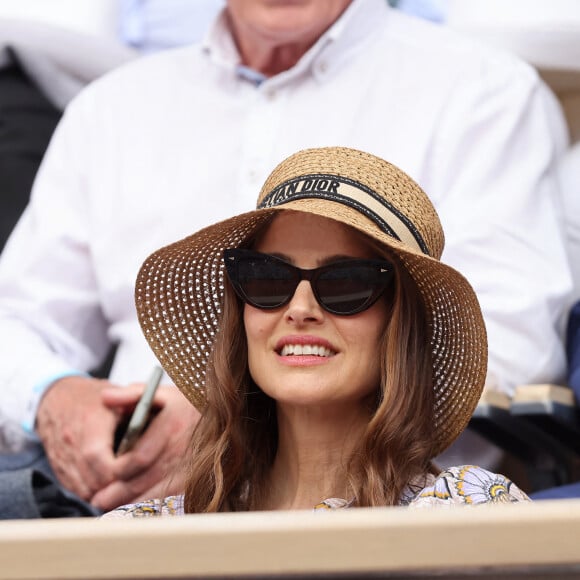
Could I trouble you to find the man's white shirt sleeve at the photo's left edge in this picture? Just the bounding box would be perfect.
[0,95,109,442]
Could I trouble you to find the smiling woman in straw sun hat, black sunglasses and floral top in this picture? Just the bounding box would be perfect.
[102,148,527,517]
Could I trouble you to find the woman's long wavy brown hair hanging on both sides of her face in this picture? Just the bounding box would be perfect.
[185,231,434,513]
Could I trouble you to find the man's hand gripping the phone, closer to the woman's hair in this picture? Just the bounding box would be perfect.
[91,385,199,510]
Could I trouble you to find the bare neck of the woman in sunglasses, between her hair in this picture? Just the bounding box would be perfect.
[260,409,368,510]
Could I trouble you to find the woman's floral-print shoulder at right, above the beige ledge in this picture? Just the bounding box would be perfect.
[402,465,530,507]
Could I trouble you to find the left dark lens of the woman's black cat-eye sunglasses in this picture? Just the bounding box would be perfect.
[238,256,297,308]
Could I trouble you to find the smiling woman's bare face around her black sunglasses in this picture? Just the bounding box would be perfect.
[244,212,388,409]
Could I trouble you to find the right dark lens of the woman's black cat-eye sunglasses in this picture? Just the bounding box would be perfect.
[316,265,390,314]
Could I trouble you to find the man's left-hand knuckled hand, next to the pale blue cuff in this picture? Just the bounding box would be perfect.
[36,377,119,501]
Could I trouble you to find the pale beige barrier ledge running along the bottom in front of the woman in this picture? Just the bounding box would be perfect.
[0,500,580,579]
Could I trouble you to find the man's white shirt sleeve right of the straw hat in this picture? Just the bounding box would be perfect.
[427,53,572,394]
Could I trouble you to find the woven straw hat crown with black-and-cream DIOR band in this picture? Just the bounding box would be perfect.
[257,147,445,259]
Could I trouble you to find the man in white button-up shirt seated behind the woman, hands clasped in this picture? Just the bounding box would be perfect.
[0,0,571,510]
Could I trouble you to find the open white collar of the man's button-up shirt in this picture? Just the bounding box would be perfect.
[202,0,388,85]
